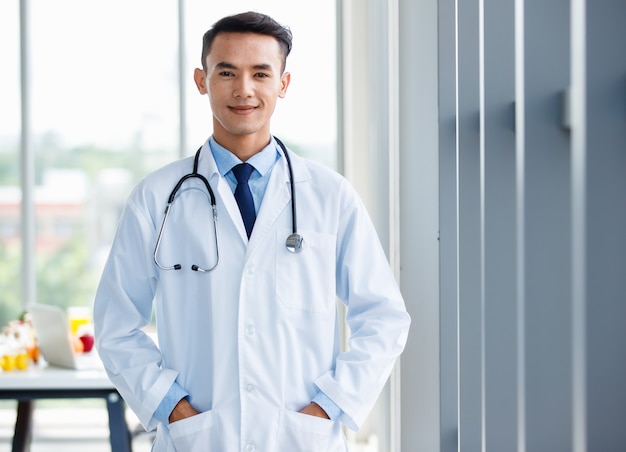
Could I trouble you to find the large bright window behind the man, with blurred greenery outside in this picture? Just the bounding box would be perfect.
[0,0,336,325]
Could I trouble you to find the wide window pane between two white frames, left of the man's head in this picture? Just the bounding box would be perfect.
[30,0,179,318]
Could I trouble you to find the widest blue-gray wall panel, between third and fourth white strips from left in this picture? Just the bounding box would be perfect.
[516,0,572,452]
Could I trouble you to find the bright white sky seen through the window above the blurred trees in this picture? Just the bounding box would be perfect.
[0,0,336,153]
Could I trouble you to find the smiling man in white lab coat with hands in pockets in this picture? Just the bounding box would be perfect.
[94,12,410,452]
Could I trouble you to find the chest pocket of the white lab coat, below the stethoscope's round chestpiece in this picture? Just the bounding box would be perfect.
[276,229,336,314]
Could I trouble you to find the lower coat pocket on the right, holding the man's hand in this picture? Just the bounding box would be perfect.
[277,411,347,452]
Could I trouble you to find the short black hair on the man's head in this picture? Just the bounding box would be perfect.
[202,11,292,72]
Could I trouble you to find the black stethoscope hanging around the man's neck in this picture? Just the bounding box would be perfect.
[153,137,304,273]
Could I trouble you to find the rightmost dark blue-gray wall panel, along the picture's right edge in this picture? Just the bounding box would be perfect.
[586,0,626,452]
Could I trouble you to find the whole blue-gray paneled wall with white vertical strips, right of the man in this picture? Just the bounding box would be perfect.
[400,0,626,452]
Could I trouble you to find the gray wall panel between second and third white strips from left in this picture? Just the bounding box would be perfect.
[481,0,517,452]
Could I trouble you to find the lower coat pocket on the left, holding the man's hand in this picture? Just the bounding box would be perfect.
[169,411,222,452]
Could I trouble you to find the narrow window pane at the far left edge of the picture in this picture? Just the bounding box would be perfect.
[0,0,21,327]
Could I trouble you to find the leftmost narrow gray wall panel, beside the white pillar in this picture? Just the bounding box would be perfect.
[436,0,459,452]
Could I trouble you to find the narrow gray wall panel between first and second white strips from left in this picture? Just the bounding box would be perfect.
[456,0,483,452]
